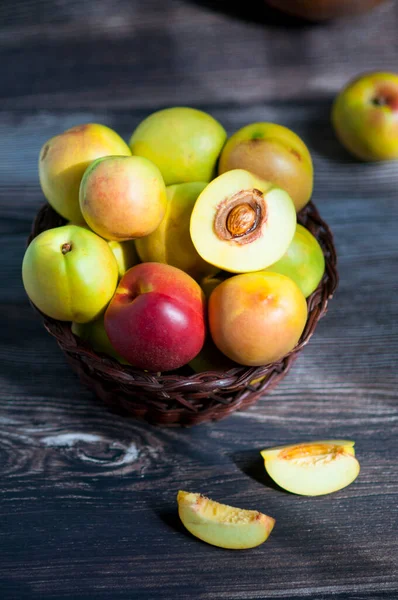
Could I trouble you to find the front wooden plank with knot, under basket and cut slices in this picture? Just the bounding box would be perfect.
[0,103,398,600]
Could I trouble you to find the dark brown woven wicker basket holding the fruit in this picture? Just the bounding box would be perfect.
[28,203,338,426]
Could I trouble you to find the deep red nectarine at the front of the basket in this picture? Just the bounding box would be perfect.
[105,263,205,371]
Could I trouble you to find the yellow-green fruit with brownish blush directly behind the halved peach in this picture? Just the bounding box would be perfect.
[218,123,314,211]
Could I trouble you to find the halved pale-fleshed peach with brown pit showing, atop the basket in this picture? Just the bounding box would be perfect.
[190,169,296,273]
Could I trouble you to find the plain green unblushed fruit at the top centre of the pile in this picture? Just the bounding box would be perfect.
[129,106,227,185]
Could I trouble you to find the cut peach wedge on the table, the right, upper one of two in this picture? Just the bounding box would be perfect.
[261,440,360,496]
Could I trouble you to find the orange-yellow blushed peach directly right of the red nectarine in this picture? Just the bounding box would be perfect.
[209,272,307,367]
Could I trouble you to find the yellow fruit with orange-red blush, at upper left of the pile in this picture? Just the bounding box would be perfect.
[39,123,131,223]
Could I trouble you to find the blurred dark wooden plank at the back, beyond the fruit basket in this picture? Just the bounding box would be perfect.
[0,0,398,110]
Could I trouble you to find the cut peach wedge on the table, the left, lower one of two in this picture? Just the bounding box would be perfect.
[177,490,275,550]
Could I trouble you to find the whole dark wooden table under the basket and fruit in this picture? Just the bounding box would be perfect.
[0,0,398,600]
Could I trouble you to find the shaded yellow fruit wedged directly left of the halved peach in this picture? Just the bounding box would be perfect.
[135,182,217,280]
